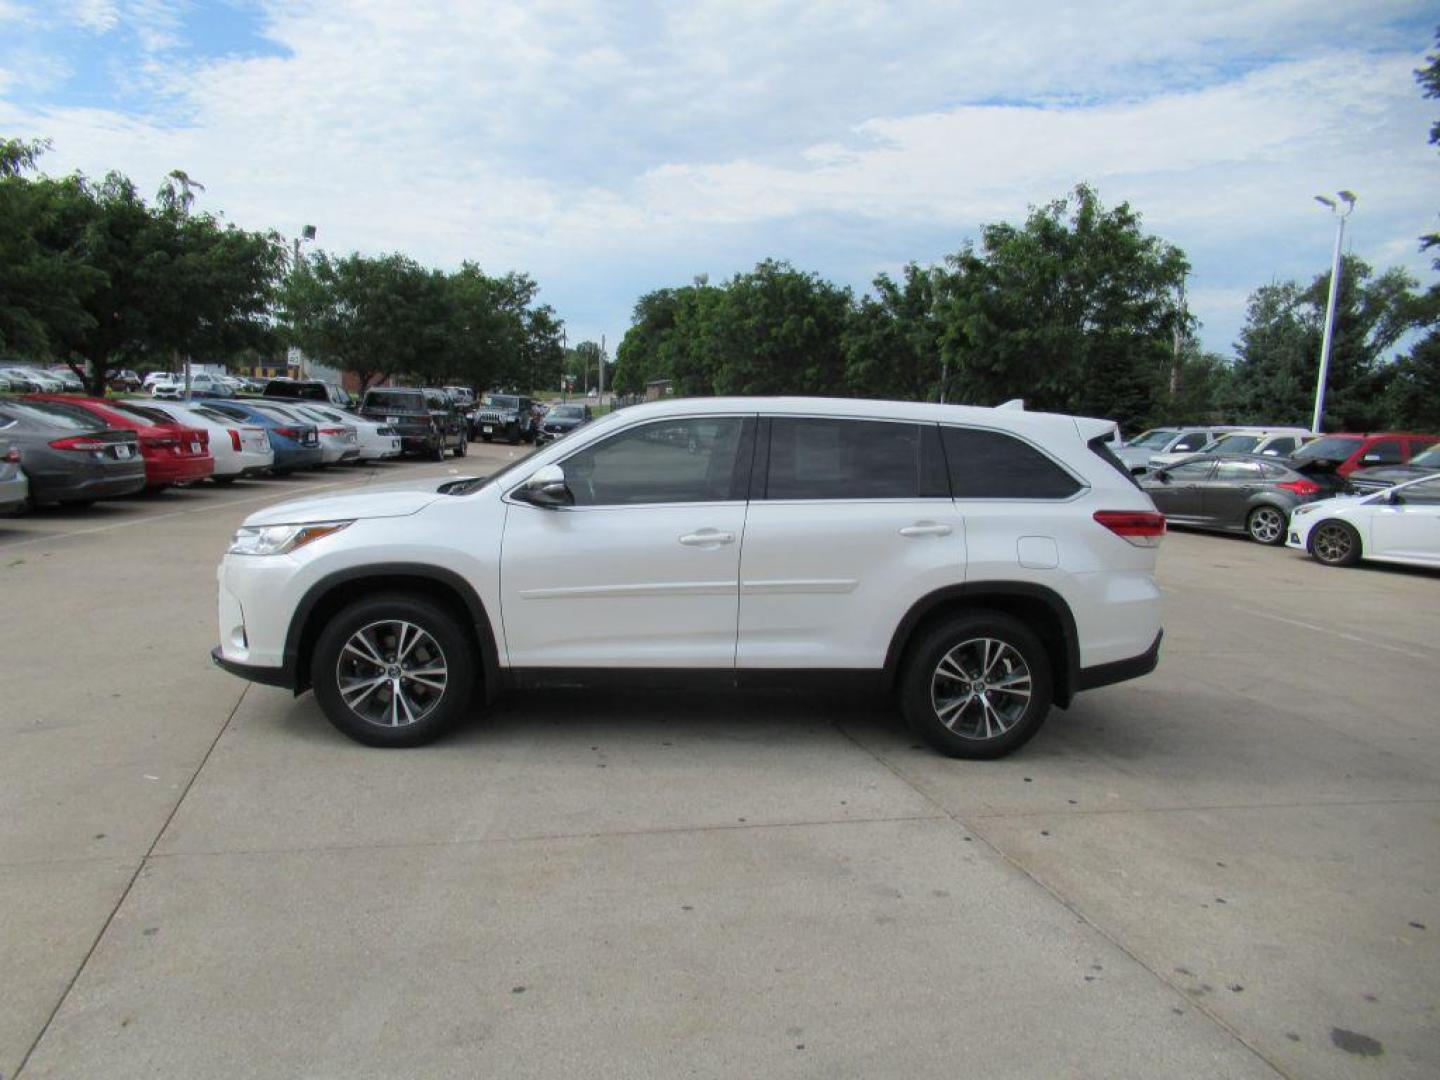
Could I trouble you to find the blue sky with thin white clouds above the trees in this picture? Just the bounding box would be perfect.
[0,0,1440,353]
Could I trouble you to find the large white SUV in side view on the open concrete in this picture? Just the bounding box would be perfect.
[213,397,1165,757]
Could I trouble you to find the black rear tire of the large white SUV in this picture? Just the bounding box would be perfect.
[900,611,1054,759]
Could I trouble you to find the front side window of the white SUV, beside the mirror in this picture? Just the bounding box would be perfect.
[560,416,742,507]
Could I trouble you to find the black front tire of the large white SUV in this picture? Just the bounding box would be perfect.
[310,593,478,747]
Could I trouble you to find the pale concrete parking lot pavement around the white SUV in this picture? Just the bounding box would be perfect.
[0,445,1440,1077]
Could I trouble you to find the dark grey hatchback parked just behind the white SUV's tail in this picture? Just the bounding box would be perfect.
[1139,454,1335,544]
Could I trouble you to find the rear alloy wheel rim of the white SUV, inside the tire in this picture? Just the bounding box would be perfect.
[930,638,1032,740]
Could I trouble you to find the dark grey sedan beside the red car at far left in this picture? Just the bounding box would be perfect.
[0,399,145,505]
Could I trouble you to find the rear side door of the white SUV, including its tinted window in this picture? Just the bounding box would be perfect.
[736,416,965,670]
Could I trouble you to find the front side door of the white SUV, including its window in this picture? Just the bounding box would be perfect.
[500,416,755,668]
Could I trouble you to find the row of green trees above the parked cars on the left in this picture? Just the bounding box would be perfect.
[0,138,566,395]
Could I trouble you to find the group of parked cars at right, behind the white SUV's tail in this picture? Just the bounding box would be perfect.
[1117,428,1440,566]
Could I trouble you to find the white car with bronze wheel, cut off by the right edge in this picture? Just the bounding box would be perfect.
[1286,475,1440,566]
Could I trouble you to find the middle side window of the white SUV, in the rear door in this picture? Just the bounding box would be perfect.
[765,418,949,498]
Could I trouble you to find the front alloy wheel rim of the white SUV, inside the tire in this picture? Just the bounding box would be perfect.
[336,619,449,727]
